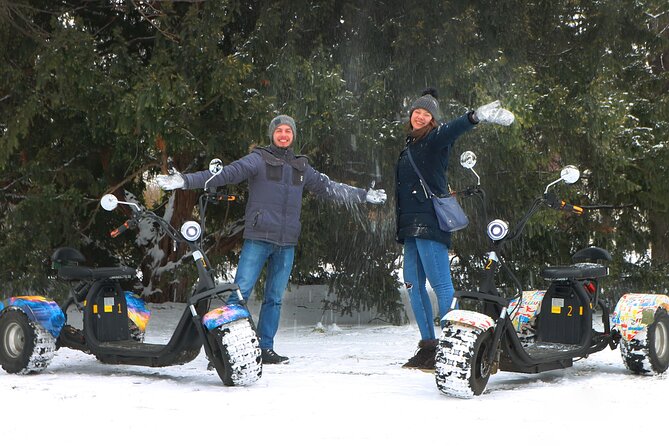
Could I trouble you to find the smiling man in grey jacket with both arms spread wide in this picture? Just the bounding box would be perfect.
[156,115,386,364]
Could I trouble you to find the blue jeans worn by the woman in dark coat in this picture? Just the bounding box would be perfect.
[404,237,453,340]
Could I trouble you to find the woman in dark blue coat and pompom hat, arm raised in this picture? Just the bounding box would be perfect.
[396,89,514,369]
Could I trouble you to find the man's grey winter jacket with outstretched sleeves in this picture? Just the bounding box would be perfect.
[184,145,367,246]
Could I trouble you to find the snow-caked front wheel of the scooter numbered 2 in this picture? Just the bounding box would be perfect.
[435,324,493,398]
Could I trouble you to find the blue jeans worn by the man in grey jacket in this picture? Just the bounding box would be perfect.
[228,240,295,349]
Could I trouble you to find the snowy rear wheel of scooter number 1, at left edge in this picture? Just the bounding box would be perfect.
[0,309,56,375]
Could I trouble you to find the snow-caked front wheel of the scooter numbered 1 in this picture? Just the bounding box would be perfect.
[210,319,262,386]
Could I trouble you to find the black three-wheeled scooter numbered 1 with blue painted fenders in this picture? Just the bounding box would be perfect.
[0,159,262,385]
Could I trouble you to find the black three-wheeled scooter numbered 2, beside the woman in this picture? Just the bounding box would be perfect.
[435,152,669,398]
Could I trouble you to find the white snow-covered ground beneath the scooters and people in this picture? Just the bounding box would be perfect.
[0,290,669,446]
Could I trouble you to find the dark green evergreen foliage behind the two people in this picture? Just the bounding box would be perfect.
[0,0,669,322]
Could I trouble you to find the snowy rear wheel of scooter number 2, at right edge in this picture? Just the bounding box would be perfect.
[620,308,669,374]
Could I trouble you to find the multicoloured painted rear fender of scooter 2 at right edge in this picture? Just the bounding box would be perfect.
[611,293,669,341]
